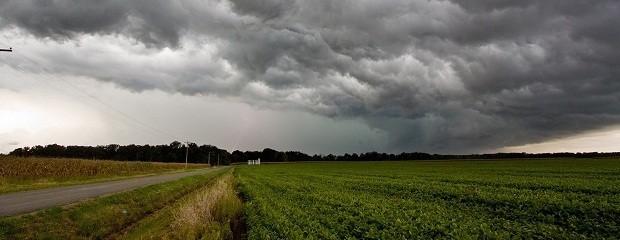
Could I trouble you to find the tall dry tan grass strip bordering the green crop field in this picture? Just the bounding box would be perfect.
[119,169,246,239]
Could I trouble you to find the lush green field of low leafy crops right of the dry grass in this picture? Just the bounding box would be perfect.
[236,159,620,239]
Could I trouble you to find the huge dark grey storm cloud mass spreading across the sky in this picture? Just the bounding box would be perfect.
[0,0,620,152]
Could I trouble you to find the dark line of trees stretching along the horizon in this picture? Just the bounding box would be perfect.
[9,141,620,165]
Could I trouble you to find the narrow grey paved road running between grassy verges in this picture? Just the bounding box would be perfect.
[0,168,221,217]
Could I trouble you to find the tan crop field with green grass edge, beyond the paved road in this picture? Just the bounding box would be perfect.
[0,156,209,194]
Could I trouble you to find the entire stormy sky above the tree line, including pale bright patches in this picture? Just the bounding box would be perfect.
[0,0,620,154]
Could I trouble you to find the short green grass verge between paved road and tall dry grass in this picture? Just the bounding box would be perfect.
[0,168,226,239]
